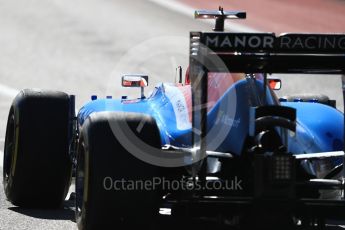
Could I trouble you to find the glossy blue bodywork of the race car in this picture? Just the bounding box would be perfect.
[78,79,344,162]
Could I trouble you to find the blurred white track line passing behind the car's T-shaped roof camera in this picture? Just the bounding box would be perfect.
[149,0,260,32]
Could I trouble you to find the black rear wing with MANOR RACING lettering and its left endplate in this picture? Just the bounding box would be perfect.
[189,32,345,164]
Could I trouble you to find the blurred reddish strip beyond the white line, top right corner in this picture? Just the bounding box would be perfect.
[179,0,345,33]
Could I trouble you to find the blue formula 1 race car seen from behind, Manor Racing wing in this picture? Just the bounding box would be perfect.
[3,9,345,229]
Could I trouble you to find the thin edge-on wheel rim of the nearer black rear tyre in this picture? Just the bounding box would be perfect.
[75,144,85,218]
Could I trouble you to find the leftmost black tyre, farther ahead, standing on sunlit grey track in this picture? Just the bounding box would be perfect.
[3,90,71,208]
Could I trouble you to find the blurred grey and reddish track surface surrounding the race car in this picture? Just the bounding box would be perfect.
[0,0,345,229]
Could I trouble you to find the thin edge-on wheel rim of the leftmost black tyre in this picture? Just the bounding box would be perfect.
[3,113,15,189]
